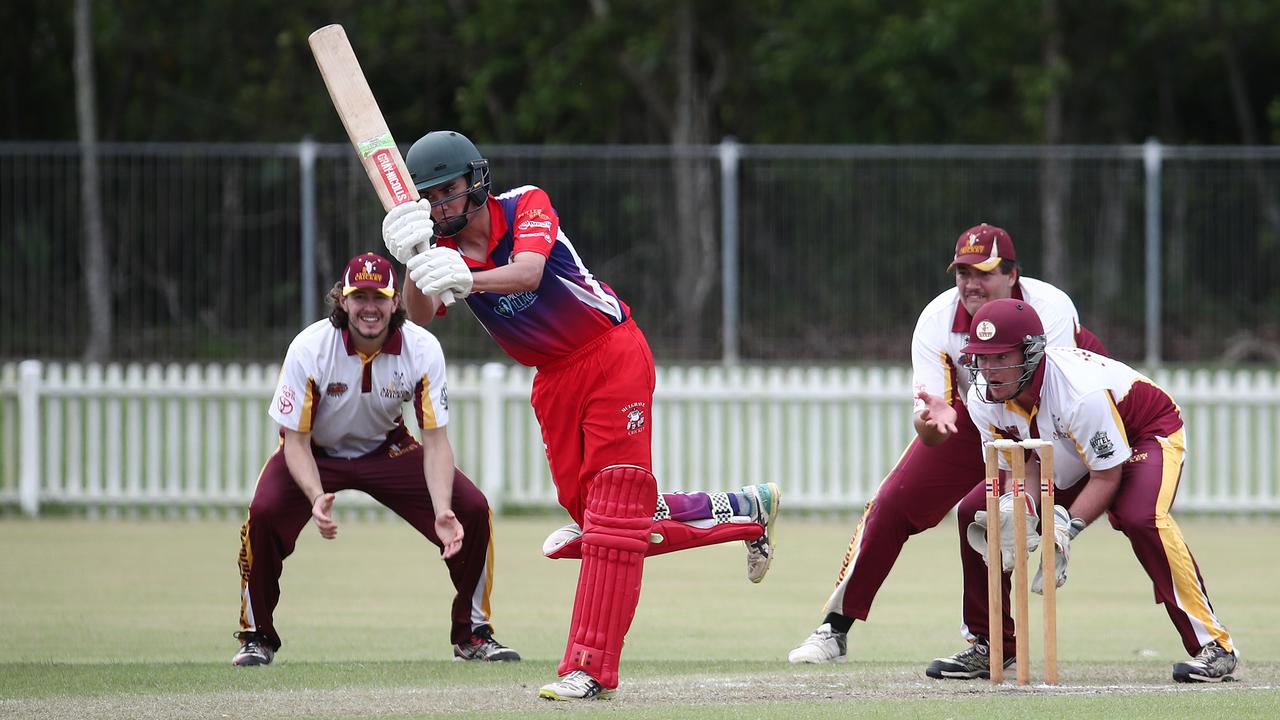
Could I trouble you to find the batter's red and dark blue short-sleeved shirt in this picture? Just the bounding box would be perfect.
[439,186,631,366]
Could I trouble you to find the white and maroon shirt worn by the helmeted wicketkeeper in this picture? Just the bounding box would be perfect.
[969,347,1183,488]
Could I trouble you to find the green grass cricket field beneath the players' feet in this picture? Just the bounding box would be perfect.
[0,516,1280,720]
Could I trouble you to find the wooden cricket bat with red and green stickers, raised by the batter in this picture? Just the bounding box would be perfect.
[308,24,454,305]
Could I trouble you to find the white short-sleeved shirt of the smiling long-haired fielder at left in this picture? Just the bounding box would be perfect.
[268,319,449,457]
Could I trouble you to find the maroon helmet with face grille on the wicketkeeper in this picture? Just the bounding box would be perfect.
[961,297,1044,402]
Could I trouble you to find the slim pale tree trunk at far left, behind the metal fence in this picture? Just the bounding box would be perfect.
[74,0,113,363]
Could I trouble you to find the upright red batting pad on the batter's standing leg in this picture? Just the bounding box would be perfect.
[559,465,658,689]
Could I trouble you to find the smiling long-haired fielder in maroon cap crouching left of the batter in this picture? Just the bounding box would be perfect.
[232,252,520,666]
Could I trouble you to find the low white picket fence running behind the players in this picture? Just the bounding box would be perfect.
[0,360,1280,515]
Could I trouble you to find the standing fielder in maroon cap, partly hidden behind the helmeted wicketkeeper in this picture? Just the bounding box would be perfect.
[787,223,1106,671]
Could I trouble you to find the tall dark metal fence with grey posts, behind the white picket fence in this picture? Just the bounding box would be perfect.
[0,142,1280,365]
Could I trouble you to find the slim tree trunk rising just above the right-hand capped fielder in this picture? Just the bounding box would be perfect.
[1039,0,1071,291]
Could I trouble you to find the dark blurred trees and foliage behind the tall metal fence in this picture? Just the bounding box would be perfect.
[0,0,1280,363]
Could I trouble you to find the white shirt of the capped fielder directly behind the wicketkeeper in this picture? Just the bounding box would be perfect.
[911,277,1080,414]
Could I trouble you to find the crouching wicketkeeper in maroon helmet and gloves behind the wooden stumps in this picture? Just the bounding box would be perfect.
[947,300,1236,683]
